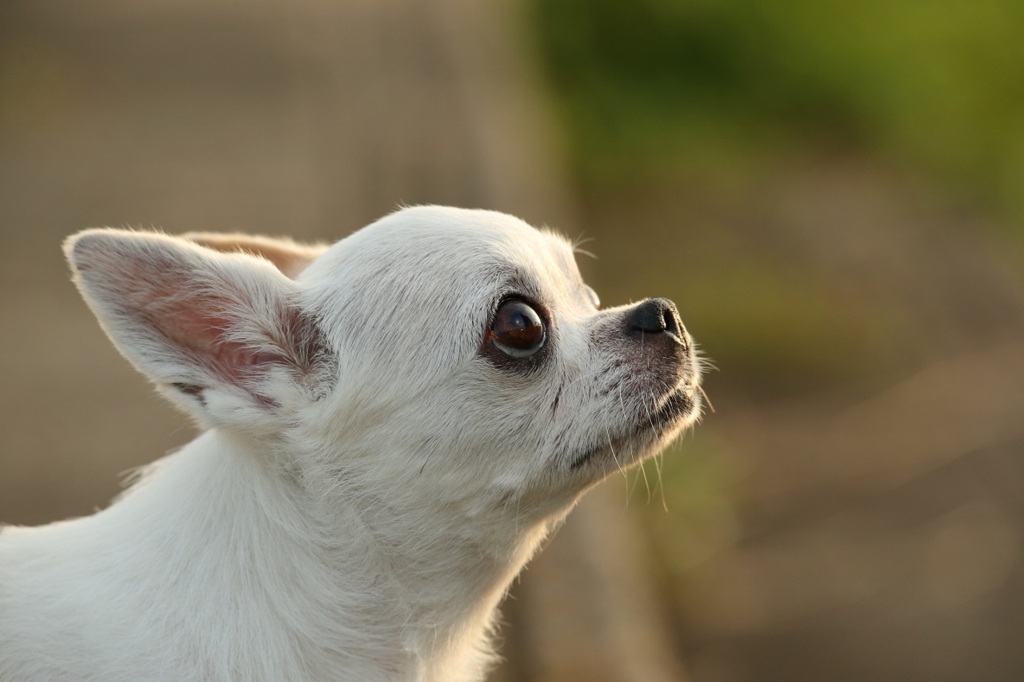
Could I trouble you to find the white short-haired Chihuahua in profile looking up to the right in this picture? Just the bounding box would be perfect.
[0,207,701,682]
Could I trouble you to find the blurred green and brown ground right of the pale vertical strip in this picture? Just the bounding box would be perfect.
[531,0,1024,681]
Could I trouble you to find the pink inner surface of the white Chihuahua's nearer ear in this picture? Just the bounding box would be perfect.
[70,232,327,404]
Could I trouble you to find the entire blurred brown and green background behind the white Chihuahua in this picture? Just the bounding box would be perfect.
[0,0,1024,682]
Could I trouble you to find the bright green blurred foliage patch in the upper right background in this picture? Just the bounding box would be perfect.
[535,0,1024,218]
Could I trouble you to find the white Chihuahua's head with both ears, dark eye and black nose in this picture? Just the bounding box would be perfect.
[67,207,699,518]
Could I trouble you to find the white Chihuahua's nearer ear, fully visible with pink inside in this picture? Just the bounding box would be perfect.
[65,229,332,431]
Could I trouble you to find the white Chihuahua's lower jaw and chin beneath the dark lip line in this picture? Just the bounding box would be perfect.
[568,385,700,476]
